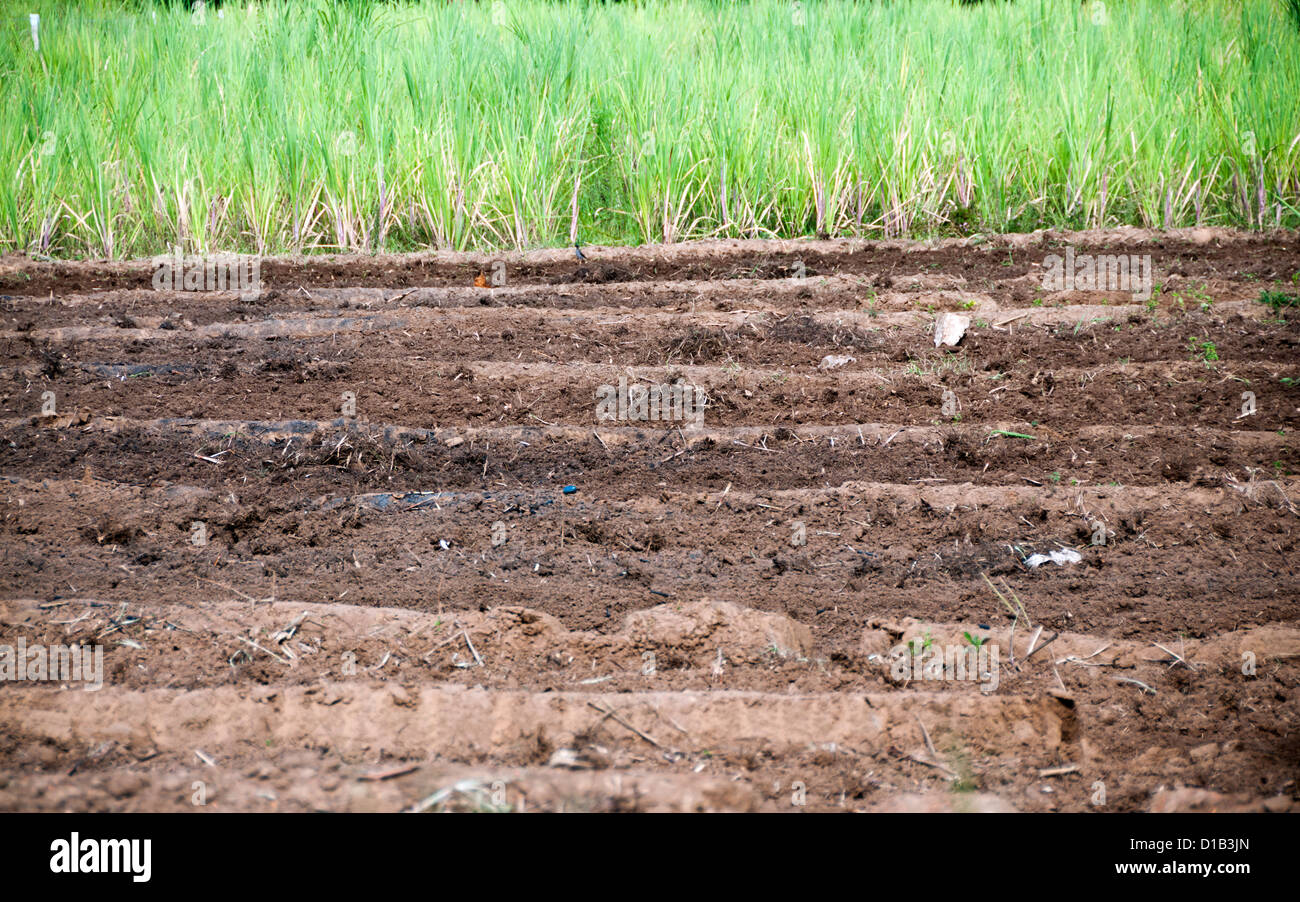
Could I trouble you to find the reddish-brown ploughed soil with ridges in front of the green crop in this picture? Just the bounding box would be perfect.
[0,230,1300,811]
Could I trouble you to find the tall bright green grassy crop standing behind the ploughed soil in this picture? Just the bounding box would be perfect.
[0,0,1300,257]
